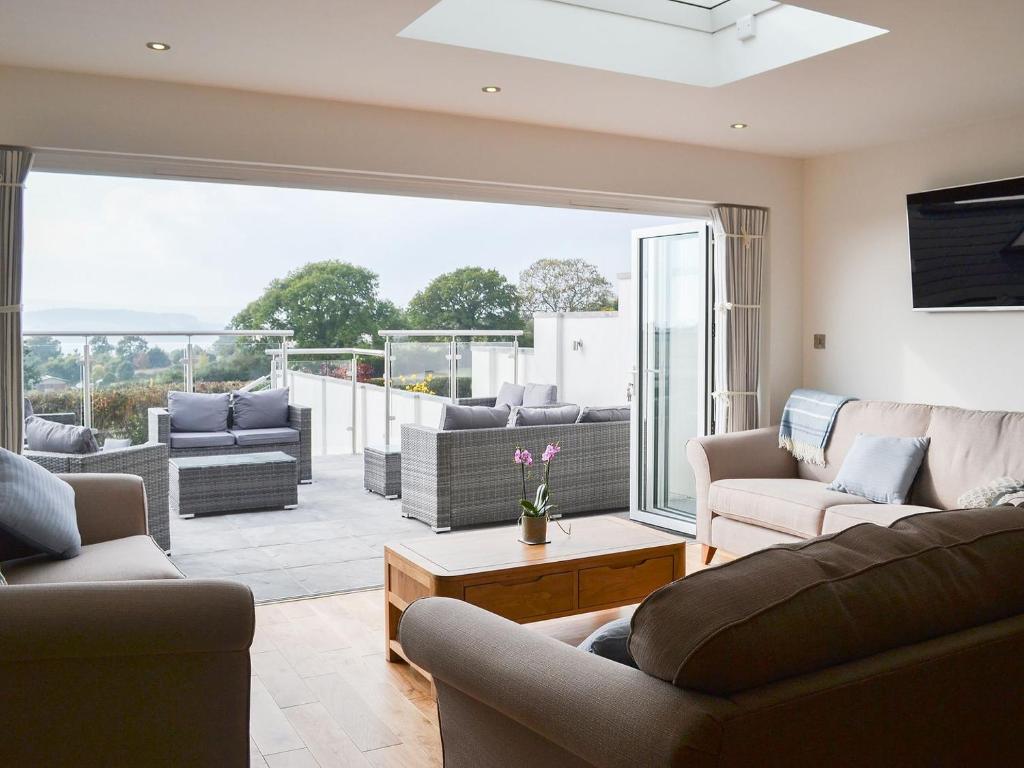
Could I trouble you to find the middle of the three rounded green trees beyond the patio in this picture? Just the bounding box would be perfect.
[408,266,522,331]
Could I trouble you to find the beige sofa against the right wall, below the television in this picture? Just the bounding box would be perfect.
[686,400,1024,562]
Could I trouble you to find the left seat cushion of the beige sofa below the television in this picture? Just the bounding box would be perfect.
[708,477,870,539]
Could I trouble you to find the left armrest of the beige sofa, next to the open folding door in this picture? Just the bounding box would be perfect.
[686,427,797,545]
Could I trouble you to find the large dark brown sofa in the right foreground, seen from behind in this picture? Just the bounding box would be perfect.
[399,507,1024,768]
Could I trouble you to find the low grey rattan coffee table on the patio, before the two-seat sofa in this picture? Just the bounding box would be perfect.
[168,451,299,517]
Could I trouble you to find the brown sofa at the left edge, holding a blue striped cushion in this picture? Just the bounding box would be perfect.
[0,474,254,768]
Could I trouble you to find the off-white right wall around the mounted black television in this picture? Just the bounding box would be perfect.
[802,112,1024,411]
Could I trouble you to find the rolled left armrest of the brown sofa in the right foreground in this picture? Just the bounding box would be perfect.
[398,598,730,768]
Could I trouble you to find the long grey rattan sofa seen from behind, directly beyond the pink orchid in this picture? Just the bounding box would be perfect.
[401,417,630,531]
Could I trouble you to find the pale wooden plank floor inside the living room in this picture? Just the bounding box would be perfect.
[250,546,724,768]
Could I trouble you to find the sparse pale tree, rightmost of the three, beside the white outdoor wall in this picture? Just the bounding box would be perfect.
[519,259,615,312]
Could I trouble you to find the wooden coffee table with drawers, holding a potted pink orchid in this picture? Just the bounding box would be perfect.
[384,517,686,662]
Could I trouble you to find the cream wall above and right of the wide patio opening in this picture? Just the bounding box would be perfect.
[0,67,803,428]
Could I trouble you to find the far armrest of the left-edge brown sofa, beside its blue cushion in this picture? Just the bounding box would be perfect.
[57,473,148,544]
